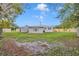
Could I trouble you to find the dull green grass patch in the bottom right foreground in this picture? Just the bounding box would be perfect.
[40,47,79,56]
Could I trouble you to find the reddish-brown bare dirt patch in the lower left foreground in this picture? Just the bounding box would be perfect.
[2,40,31,55]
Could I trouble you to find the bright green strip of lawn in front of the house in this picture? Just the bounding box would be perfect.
[3,32,75,42]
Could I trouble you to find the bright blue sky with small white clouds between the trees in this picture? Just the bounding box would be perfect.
[15,3,63,27]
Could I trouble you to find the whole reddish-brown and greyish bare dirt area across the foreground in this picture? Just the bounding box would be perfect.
[2,40,64,56]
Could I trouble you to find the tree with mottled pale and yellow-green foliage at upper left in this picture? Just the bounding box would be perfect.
[0,3,23,39]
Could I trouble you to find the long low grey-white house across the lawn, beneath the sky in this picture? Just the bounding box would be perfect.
[20,26,52,33]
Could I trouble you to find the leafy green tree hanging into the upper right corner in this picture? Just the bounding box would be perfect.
[59,3,79,28]
